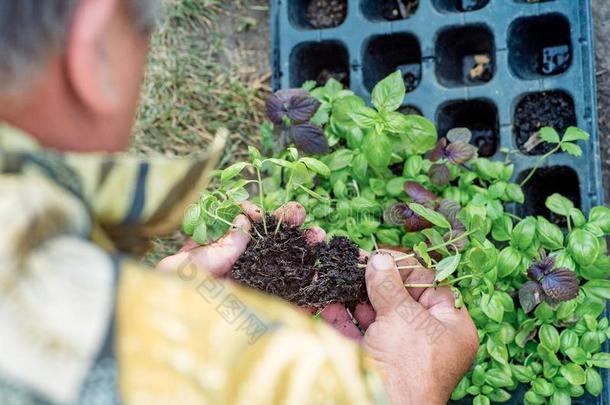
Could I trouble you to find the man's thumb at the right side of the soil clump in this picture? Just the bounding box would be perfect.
[366,252,413,316]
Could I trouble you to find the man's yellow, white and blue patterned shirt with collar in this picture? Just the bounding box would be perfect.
[0,125,385,405]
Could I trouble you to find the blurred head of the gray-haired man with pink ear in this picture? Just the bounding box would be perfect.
[0,0,158,151]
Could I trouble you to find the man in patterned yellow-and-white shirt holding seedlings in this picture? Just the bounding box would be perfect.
[0,0,478,404]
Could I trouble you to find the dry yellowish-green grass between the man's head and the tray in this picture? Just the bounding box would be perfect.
[131,0,269,264]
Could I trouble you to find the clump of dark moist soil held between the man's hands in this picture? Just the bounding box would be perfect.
[233,216,368,307]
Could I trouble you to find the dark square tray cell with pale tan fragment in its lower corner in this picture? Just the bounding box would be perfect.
[436,25,495,87]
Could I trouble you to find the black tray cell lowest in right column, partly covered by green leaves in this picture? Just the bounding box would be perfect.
[519,166,581,226]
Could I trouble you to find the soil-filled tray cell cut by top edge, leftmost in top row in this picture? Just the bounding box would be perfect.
[288,0,347,29]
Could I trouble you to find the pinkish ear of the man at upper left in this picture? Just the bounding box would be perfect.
[64,0,120,114]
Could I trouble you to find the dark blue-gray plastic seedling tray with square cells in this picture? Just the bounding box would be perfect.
[271,0,610,405]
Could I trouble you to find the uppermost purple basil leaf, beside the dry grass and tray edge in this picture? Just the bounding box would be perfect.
[266,89,320,125]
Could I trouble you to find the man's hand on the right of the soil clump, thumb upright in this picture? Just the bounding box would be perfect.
[356,251,479,405]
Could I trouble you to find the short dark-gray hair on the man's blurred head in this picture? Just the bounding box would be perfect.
[0,0,159,94]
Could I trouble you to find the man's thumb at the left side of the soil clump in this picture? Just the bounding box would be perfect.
[189,215,252,277]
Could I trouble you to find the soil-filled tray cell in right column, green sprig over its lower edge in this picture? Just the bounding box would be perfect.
[513,90,576,155]
